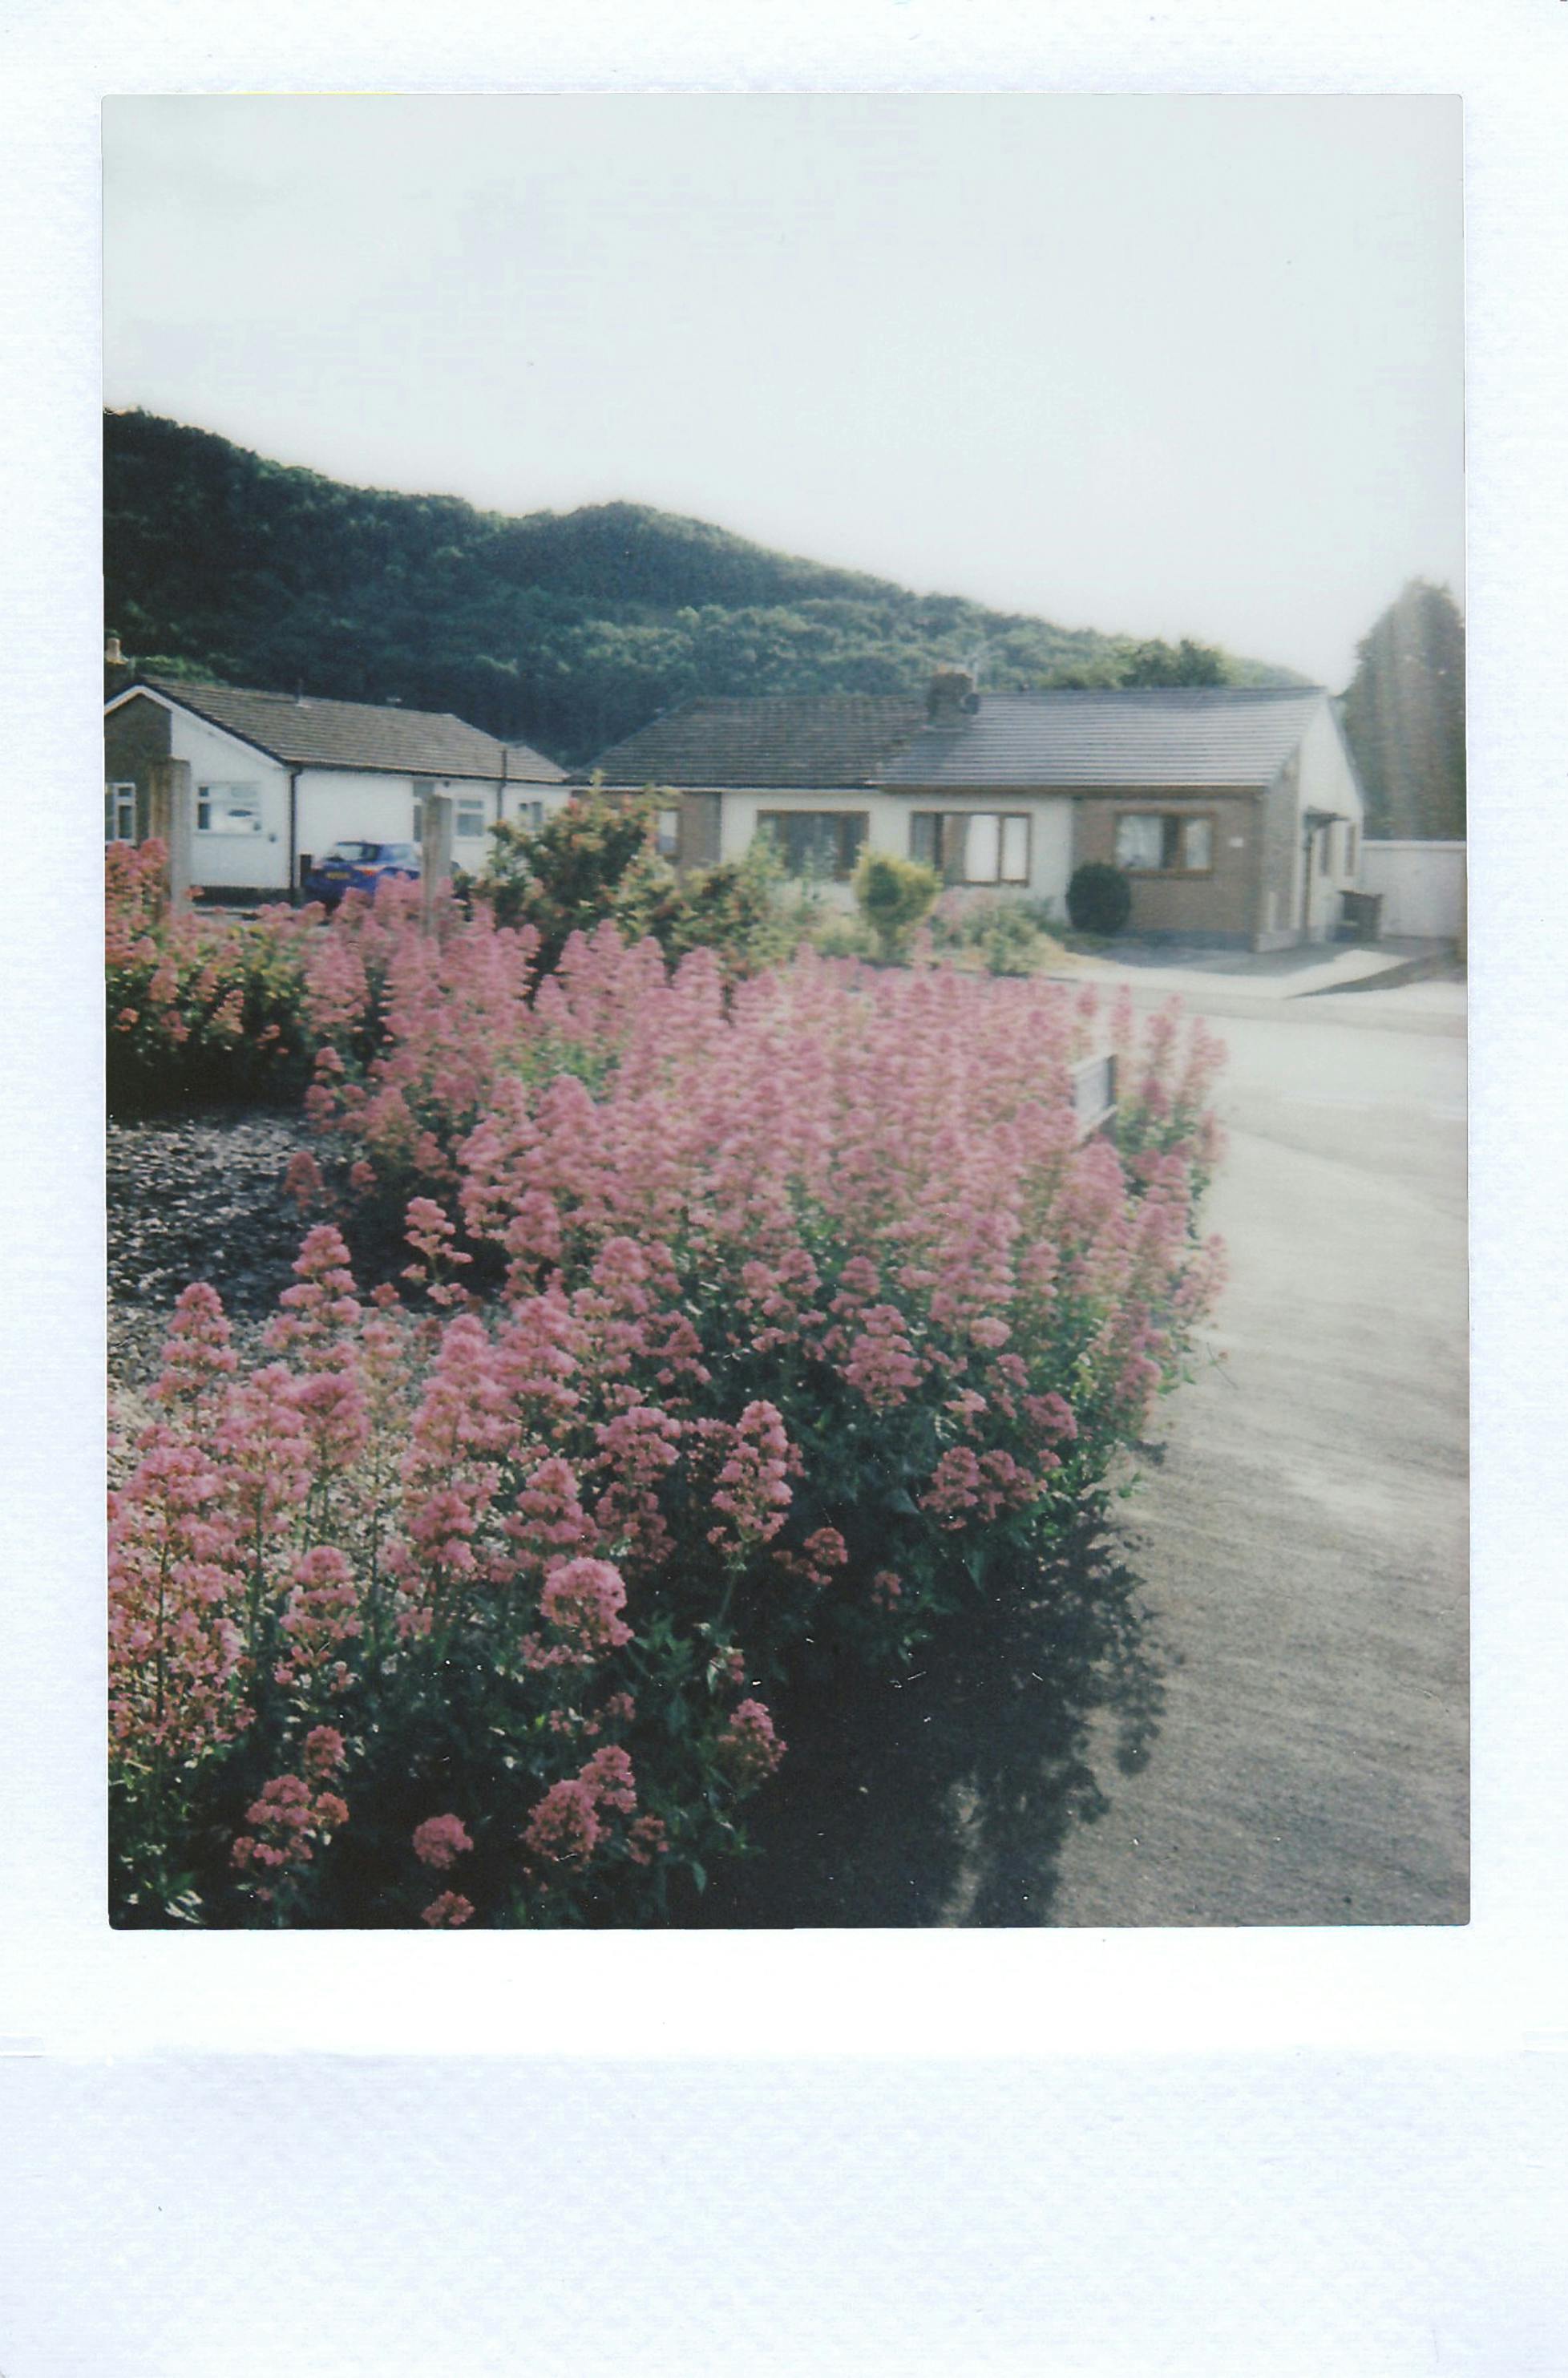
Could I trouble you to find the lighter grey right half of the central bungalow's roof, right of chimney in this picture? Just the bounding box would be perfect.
[875,685,1325,790]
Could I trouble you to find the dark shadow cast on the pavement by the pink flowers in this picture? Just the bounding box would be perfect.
[683,1507,1163,1928]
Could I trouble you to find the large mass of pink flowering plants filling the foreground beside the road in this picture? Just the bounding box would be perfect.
[112,901,1221,1928]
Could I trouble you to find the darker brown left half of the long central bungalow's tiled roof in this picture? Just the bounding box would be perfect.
[592,694,926,790]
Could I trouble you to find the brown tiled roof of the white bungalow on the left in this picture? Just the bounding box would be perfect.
[129,677,564,785]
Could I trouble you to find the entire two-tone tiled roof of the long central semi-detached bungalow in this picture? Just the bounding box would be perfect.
[595,685,1325,790]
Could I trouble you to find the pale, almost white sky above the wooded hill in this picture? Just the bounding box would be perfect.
[105,95,1463,690]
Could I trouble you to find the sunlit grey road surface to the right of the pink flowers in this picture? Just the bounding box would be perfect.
[1052,982,1468,1926]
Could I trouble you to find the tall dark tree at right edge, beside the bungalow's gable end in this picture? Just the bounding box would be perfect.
[1344,578,1465,842]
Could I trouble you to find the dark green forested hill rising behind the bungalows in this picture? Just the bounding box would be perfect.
[105,411,1295,763]
